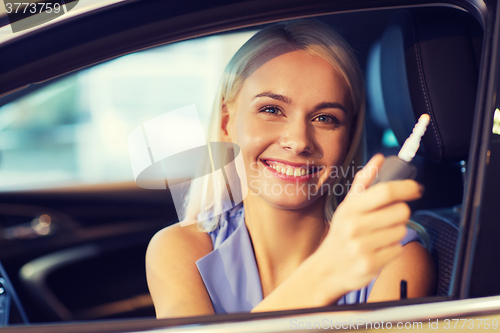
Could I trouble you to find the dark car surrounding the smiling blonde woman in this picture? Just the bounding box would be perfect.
[0,0,500,332]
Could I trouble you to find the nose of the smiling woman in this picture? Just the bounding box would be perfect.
[279,118,314,155]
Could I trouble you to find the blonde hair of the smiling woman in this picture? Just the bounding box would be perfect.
[185,19,365,231]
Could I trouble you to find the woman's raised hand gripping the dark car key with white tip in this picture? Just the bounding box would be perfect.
[313,155,422,302]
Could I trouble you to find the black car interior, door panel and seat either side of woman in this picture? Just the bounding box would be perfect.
[0,1,483,326]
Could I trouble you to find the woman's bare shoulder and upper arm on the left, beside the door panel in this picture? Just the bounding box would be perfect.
[146,223,214,318]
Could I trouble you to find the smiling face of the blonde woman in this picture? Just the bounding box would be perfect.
[222,51,352,209]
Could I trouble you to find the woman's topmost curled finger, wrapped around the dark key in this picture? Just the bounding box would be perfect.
[349,179,423,212]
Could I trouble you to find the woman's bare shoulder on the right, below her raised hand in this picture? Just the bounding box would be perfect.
[368,242,436,302]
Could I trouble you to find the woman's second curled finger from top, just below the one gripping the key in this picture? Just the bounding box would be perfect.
[359,202,411,233]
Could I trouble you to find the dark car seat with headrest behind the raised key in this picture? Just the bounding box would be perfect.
[367,7,482,296]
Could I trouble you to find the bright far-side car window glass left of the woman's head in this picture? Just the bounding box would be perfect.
[0,32,254,190]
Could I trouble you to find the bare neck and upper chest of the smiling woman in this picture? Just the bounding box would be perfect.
[244,193,328,297]
